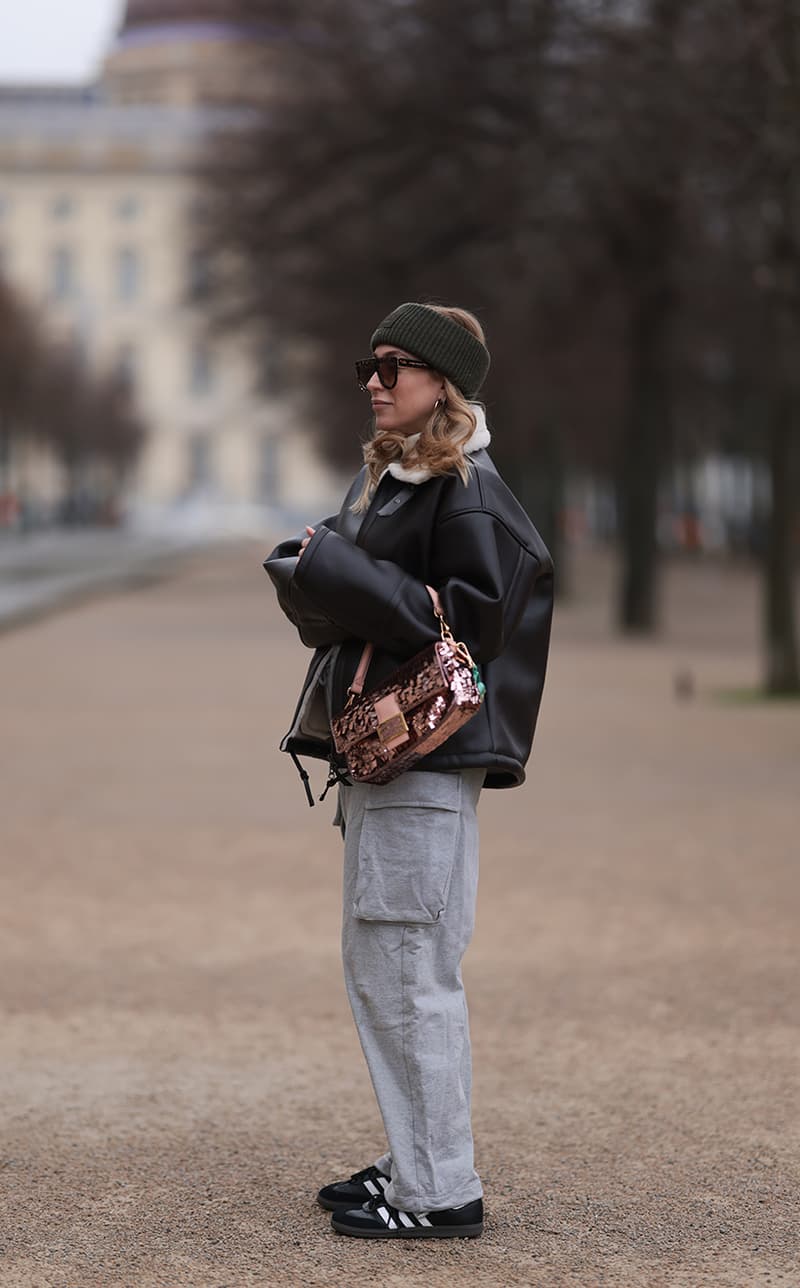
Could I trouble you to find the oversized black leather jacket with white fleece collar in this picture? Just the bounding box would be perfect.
[264,450,553,799]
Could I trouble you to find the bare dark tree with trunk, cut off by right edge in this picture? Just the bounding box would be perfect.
[685,0,800,693]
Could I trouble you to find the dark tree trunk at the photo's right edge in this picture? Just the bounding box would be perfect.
[764,390,800,694]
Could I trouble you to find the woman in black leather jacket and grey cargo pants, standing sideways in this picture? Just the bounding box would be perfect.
[264,304,553,1239]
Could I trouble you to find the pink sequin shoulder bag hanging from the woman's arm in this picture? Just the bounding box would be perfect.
[331,586,486,783]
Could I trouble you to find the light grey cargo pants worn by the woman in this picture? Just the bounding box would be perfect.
[336,769,486,1212]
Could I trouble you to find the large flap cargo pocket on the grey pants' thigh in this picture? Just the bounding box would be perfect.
[353,773,461,925]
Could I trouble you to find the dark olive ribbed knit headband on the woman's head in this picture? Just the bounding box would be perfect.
[372,304,490,398]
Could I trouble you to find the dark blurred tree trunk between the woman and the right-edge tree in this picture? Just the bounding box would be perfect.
[617,295,670,635]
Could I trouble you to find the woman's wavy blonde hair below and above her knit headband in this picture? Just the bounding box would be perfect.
[352,304,486,514]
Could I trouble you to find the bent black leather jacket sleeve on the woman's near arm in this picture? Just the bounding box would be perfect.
[289,510,538,662]
